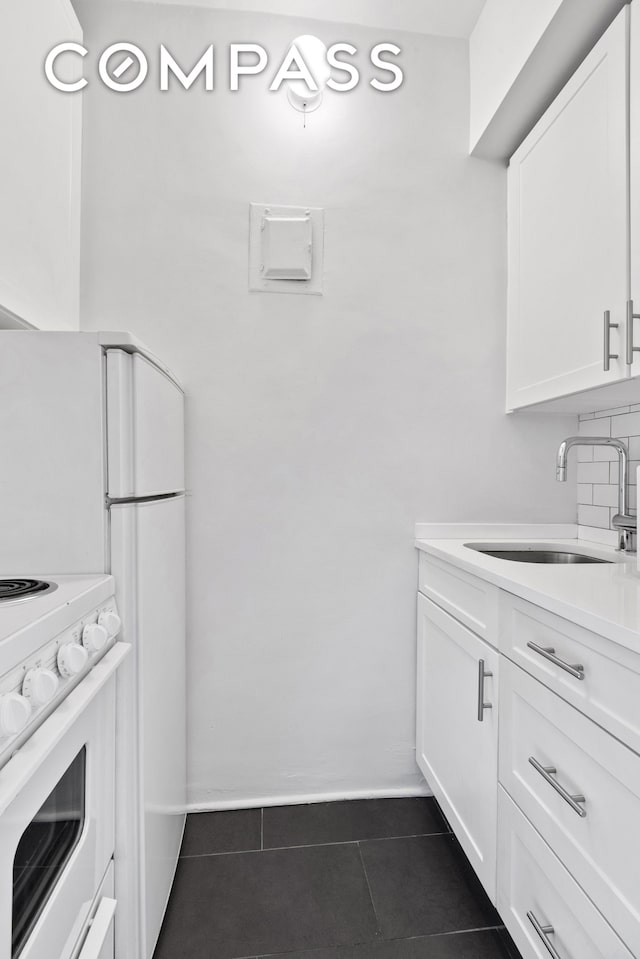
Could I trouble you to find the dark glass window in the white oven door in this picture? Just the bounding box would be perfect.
[11,747,87,959]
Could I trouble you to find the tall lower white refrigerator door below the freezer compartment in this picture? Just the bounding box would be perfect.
[111,496,186,959]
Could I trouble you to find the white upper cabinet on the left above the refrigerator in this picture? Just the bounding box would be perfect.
[0,0,82,330]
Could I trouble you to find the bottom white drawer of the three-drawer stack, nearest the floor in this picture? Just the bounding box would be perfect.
[498,788,632,959]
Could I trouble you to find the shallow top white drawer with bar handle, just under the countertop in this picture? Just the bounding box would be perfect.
[499,592,640,753]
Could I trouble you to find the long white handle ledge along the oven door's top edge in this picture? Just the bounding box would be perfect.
[0,643,131,815]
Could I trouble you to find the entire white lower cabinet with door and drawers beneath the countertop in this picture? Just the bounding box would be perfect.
[416,556,640,959]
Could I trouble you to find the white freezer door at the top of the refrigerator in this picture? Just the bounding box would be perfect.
[107,350,184,499]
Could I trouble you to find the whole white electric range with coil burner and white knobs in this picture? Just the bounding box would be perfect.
[0,575,130,959]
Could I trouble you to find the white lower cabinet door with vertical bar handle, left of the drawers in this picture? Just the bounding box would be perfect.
[416,594,499,903]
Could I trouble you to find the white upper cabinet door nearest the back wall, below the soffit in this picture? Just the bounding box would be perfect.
[507,7,640,409]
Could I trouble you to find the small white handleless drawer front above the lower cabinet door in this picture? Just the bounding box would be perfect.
[418,552,500,646]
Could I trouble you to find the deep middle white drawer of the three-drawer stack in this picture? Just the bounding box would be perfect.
[499,659,640,956]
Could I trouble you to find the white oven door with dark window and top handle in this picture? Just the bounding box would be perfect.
[0,643,129,959]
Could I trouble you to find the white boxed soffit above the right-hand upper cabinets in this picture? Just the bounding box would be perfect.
[469,0,628,159]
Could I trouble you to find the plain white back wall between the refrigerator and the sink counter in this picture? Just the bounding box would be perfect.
[75,3,576,805]
